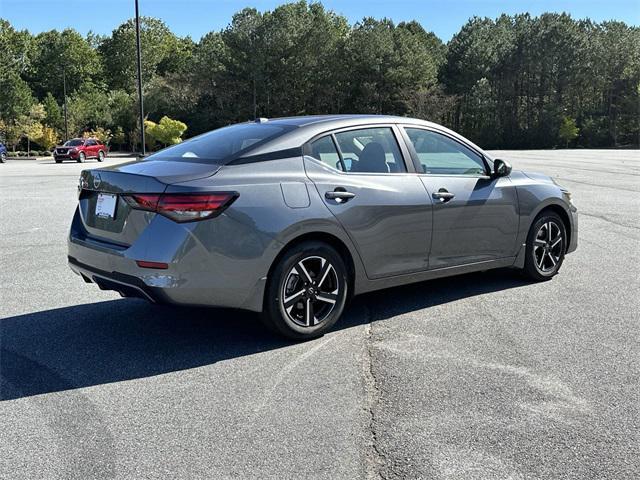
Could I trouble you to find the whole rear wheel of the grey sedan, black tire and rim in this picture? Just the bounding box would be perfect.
[262,241,349,340]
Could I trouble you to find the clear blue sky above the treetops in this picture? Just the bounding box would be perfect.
[0,0,640,42]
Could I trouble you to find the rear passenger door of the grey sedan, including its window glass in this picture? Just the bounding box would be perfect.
[304,125,431,278]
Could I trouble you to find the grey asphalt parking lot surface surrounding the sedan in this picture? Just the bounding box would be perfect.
[0,150,640,480]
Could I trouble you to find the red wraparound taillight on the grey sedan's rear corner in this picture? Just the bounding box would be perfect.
[124,192,238,222]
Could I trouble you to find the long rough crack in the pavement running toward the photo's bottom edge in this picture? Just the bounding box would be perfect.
[363,306,386,480]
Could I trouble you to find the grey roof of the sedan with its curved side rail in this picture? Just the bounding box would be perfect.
[243,114,482,157]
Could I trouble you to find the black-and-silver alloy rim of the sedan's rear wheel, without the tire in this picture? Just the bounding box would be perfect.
[280,256,341,327]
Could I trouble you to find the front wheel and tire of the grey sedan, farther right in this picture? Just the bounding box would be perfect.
[523,211,567,282]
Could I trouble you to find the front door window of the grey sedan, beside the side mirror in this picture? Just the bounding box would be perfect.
[405,128,486,175]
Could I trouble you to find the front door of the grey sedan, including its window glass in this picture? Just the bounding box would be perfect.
[404,126,519,269]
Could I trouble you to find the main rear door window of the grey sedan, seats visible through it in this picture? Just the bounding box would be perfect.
[336,127,407,173]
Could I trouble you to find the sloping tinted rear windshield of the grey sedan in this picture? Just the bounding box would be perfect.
[147,123,295,165]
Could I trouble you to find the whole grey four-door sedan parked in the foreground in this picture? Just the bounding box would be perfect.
[68,115,578,339]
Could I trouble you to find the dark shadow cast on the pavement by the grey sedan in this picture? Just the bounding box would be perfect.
[0,270,527,400]
